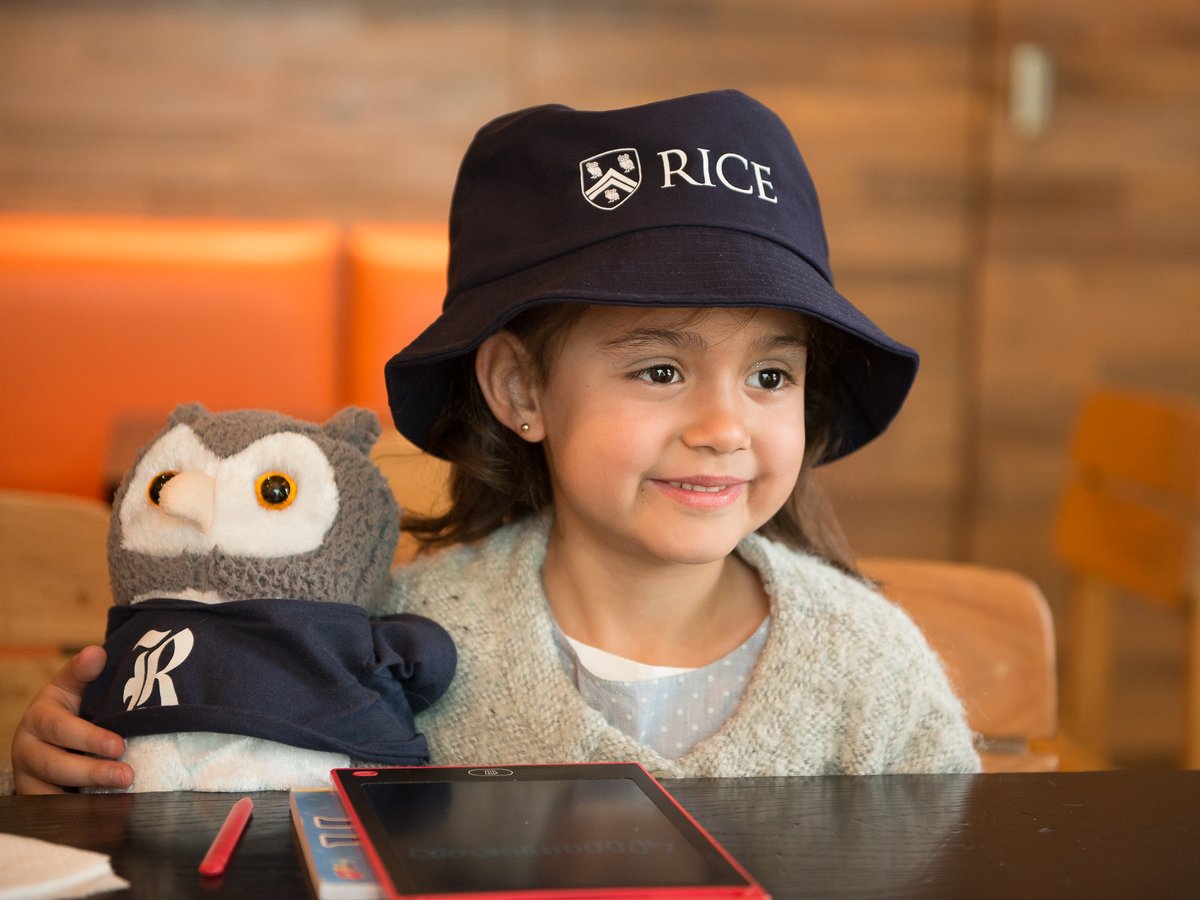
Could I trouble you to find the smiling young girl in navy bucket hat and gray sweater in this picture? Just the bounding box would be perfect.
[13,91,979,791]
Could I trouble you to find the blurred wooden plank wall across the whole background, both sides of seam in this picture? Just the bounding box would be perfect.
[0,0,1200,763]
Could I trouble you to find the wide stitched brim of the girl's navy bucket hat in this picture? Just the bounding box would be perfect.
[384,226,918,462]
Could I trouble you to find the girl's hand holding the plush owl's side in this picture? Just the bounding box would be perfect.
[12,647,133,793]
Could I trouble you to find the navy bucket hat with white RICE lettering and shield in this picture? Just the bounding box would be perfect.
[385,91,918,462]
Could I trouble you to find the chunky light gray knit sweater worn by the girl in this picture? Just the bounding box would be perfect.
[379,517,979,778]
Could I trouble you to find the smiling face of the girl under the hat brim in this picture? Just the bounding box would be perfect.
[538,306,808,564]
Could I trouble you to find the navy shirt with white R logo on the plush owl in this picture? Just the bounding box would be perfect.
[82,600,457,766]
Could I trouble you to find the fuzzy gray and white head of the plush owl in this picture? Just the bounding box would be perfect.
[108,403,398,607]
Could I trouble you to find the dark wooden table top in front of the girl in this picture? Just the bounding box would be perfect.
[0,772,1200,900]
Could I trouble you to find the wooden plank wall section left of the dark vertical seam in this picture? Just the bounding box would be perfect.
[0,0,978,557]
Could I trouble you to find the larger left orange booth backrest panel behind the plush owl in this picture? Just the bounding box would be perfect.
[0,215,348,497]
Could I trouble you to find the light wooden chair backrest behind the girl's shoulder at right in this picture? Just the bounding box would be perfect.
[859,557,1058,772]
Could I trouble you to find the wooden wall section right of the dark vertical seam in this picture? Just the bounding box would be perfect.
[967,0,1200,764]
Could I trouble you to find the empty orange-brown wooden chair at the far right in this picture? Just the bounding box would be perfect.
[1056,389,1200,768]
